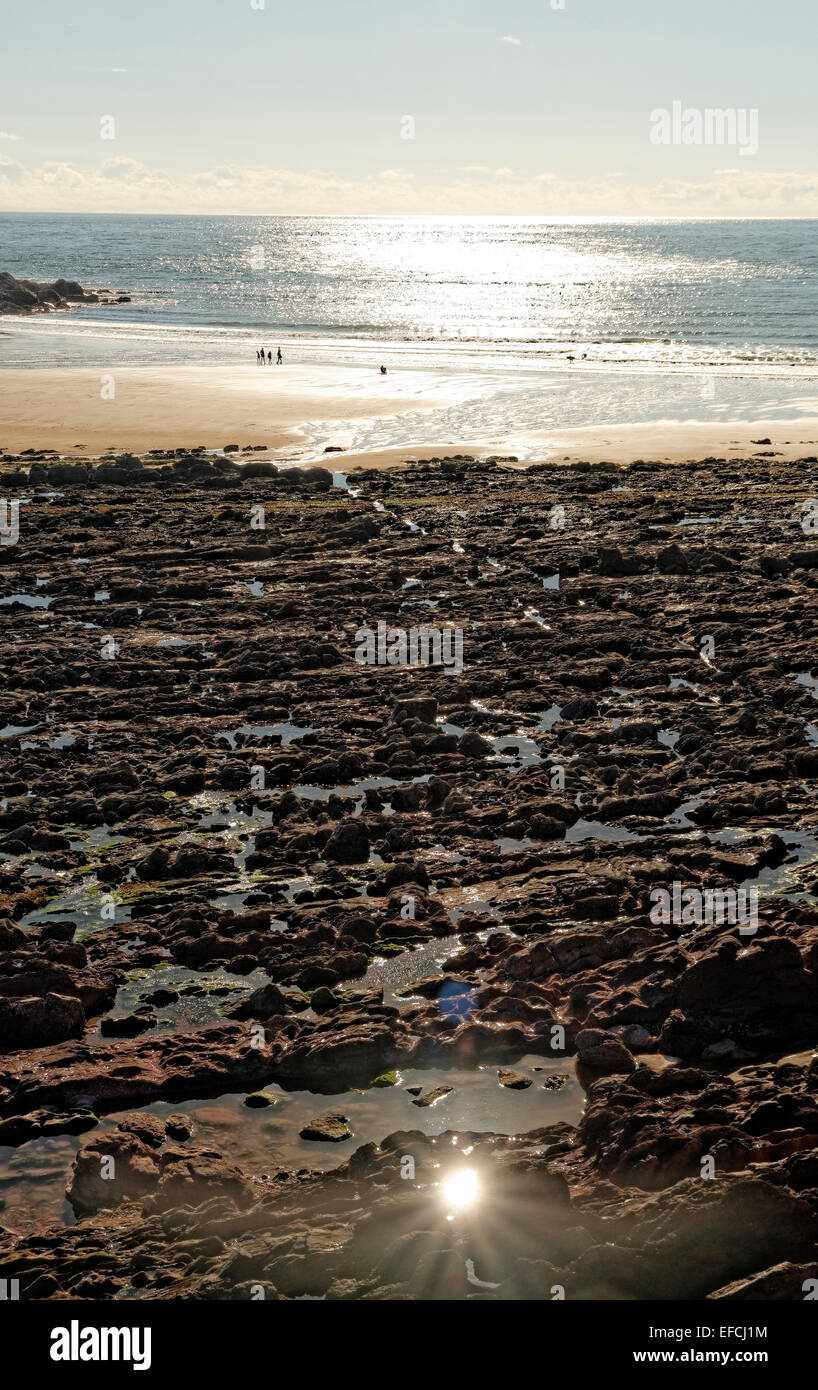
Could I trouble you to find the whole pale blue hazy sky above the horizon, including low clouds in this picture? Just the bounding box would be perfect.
[0,0,818,217]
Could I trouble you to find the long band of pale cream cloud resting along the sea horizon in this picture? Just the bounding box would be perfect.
[0,156,818,217]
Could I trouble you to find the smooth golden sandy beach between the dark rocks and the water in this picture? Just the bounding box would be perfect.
[0,366,818,468]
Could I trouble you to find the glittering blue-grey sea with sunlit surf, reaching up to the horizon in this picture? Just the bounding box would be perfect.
[0,213,818,448]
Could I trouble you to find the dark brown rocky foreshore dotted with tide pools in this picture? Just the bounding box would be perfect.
[0,449,818,1300]
